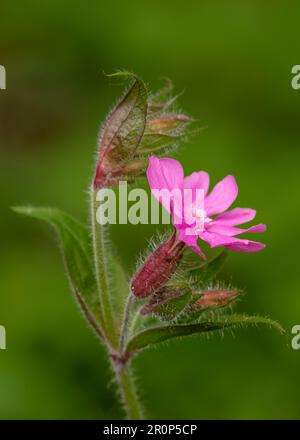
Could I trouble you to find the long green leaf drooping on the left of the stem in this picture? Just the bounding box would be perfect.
[13,207,102,334]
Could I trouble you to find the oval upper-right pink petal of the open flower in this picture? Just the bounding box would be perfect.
[205,176,238,215]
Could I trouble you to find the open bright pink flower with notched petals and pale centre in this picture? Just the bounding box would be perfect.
[147,156,266,259]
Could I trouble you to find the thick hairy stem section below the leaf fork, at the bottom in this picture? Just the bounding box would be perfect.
[116,366,143,420]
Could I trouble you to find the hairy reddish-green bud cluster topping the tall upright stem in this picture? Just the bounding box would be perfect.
[93,74,191,190]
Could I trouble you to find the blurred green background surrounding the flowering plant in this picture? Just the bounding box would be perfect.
[0,0,300,419]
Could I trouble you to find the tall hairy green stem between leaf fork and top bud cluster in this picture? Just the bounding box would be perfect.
[91,189,118,348]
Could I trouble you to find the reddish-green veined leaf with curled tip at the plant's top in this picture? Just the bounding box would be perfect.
[99,72,147,166]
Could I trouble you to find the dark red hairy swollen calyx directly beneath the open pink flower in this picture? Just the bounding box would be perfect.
[131,232,185,298]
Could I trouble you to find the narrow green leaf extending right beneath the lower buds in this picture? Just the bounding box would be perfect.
[126,315,284,354]
